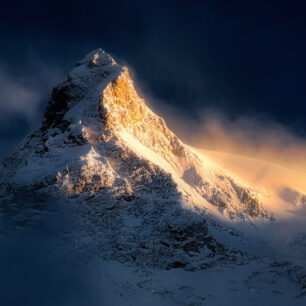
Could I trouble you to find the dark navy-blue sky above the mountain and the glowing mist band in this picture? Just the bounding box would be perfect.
[0,0,306,157]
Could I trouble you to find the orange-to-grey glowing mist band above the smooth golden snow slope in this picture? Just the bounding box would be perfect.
[149,98,306,172]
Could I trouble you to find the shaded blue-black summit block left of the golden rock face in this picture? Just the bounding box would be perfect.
[42,48,123,131]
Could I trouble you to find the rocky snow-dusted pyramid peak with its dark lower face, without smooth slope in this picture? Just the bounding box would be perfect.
[0,49,282,268]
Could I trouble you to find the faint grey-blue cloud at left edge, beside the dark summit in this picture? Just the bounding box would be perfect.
[0,58,63,125]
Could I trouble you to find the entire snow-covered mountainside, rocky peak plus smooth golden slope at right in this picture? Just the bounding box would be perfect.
[0,49,306,305]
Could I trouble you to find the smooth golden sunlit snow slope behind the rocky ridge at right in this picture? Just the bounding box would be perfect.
[195,149,306,218]
